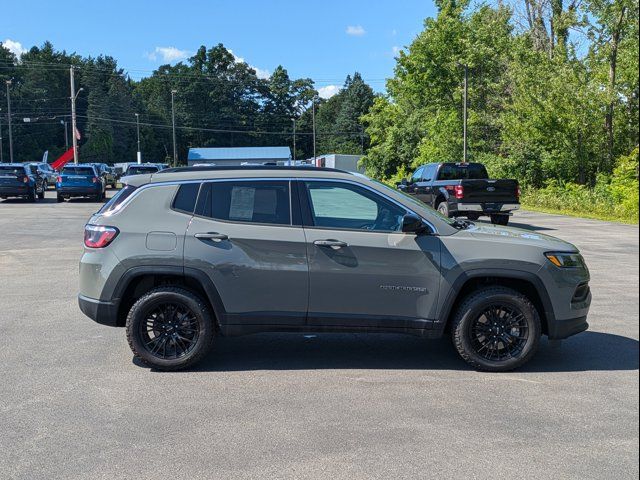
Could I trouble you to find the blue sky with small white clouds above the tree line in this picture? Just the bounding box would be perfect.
[0,0,435,96]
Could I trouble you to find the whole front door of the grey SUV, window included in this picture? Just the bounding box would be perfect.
[301,181,440,328]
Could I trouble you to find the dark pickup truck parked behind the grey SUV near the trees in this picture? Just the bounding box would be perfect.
[397,163,520,225]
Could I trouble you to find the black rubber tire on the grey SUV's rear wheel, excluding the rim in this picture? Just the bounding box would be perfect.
[126,291,214,370]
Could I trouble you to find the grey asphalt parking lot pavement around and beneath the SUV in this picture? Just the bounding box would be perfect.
[0,192,638,480]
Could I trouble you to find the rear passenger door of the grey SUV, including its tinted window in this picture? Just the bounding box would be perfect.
[184,181,309,325]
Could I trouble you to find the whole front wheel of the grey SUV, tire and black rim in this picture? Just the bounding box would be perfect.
[451,286,542,372]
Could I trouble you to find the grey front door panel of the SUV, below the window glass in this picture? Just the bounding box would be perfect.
[305,228,440,327]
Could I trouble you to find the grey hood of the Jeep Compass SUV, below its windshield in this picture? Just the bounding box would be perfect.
[460,224,578,252]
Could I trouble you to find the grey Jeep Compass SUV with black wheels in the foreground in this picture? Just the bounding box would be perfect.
[79,167,591,371]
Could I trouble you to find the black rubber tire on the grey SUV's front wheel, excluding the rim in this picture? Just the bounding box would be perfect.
[456,292,541,371]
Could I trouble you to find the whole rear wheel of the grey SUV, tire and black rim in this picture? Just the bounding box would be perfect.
[126,287,215,371]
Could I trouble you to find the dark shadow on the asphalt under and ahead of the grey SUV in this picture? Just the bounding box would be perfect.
[168,332,638,372]
